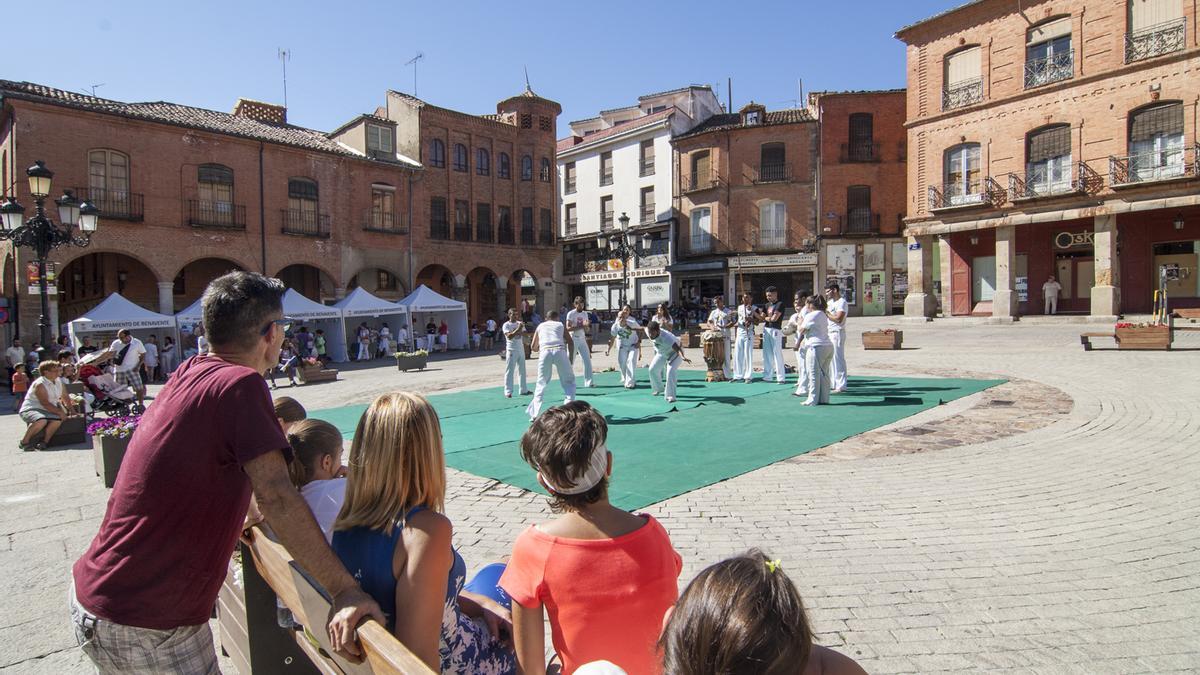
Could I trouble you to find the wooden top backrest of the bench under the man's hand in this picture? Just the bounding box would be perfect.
[242,527,433,674]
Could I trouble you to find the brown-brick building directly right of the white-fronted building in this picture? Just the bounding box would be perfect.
[671,102,818,312]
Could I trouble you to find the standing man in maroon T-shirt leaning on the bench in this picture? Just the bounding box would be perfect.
[71,271,383,673]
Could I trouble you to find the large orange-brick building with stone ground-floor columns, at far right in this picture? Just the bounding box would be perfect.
[896,0,1200,319]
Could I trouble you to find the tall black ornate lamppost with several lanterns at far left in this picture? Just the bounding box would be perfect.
[0,160,100,347]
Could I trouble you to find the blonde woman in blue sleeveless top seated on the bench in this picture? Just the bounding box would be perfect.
[334,392,516,674]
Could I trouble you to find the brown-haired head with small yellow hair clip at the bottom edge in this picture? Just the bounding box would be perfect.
[659,550,866,675]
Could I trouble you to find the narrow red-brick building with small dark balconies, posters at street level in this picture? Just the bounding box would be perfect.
[809,89,908,316]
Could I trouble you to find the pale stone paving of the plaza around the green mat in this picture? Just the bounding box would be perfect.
[0,318,1200,673]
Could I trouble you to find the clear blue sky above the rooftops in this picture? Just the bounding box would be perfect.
[0,0,961,136]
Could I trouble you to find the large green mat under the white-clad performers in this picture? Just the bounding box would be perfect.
[312,369,1004,509]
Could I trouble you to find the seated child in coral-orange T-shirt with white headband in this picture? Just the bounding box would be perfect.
[500,401,683,675]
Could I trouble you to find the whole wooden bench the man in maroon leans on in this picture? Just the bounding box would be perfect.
[218,526,433,675]
